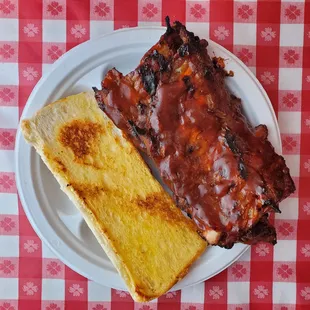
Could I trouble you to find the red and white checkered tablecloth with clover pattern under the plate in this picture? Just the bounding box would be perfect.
[0,0,310,310]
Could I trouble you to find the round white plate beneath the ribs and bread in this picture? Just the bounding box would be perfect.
[16,27,281,290]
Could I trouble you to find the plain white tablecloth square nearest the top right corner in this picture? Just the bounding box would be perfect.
[280,24,304,46]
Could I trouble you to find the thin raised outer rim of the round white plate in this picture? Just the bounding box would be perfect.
[14,26,282,291]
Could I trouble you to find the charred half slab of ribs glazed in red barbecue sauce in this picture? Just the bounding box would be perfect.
[95,19,295,248]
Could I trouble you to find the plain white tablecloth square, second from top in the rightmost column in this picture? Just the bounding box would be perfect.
[279,68,302,90]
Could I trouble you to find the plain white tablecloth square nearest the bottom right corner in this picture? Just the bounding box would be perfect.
[272,282,296,305]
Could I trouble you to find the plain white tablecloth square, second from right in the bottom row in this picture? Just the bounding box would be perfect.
[227,282,250,305]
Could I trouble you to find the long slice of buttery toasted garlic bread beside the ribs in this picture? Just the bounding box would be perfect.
[21,93,206,301]
